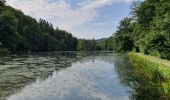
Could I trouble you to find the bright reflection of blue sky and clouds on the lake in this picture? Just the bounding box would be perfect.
[8,56,128,100]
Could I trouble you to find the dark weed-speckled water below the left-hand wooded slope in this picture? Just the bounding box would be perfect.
[0,52,81,100]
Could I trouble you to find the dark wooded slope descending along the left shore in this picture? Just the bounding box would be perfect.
[0,0,78,53]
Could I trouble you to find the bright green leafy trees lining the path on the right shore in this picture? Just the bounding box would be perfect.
[107,0,170,59]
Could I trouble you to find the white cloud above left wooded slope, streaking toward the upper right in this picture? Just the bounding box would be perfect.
[6,0,134,38]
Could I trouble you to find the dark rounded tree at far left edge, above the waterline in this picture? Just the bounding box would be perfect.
[0,11,20,51]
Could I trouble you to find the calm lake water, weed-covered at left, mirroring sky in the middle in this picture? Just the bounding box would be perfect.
[0,52,138,100]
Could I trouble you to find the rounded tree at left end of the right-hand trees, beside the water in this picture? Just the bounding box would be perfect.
[114,17,134,52]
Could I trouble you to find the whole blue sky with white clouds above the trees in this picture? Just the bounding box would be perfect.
[6,0,136,39]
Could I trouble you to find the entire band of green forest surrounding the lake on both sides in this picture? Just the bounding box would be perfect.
[0,0,170,59]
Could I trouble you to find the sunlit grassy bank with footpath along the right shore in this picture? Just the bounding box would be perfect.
[128,52,170,100]
